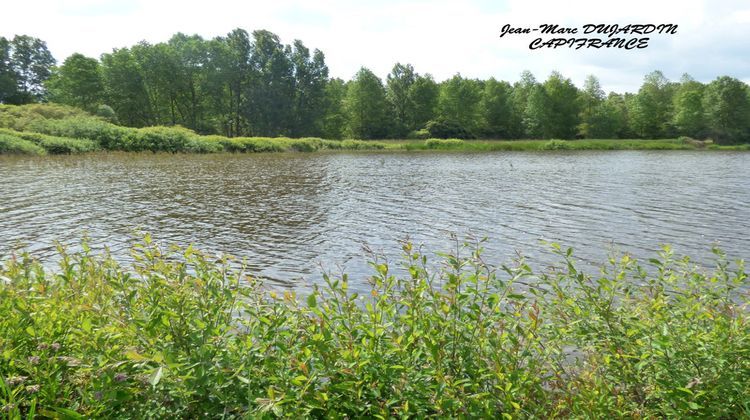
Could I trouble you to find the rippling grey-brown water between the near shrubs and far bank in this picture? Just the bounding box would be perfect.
[0,151,750,287]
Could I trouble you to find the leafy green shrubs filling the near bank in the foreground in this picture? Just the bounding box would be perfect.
[0,237,750,418]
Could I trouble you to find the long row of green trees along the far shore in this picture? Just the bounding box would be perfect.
[0,29,750,143]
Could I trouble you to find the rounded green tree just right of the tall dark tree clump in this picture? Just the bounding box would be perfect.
[346,67,390,139]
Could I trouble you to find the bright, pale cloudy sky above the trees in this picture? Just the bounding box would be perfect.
[0,0,750,92]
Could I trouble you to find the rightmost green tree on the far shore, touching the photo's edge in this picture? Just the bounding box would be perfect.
[703,76,750,143]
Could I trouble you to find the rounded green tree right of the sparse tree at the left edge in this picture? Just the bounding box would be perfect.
[47,53,104,112]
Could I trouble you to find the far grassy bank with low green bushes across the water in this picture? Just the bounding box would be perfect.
[0,104,750,154]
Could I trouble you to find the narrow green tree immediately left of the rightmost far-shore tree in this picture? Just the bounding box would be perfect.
[674,74,706,137]
